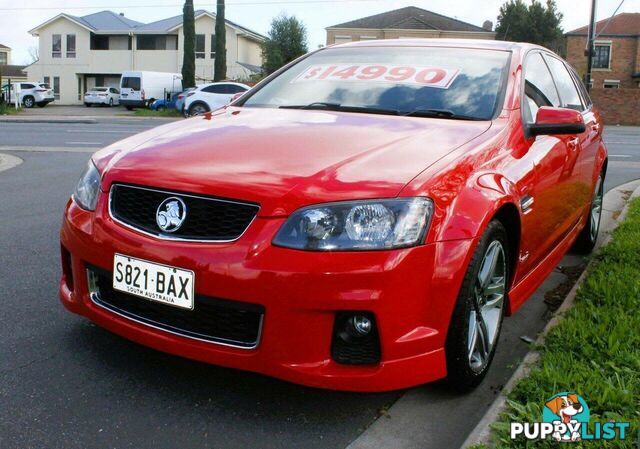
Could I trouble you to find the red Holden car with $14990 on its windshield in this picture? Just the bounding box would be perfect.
[60,39,608,391]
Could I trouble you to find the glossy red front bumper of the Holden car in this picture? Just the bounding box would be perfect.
[60,194,475,391]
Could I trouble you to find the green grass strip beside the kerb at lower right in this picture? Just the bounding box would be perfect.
[484,199,640,449]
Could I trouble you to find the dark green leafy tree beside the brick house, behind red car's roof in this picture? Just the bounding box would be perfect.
[496,0,564,52]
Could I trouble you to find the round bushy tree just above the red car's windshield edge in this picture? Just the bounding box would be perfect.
[262,14,308,74]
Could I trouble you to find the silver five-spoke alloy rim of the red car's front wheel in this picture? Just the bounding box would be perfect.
[467,240,507,372]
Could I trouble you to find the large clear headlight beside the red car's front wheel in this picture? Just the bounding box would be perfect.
[273,198,433,251]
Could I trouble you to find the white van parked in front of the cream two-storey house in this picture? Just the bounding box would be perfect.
[120,71,182,110]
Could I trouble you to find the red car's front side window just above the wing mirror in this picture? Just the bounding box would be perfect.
[522,52,560,123]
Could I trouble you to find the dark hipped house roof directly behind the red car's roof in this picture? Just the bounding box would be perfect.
[327,6,490,33]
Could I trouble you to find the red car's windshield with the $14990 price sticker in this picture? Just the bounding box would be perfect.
[241,47,510,120]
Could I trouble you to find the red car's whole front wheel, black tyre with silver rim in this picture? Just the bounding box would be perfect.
[445,220,510,392]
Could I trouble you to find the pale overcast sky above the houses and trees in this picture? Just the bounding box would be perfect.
[0,0,640,64]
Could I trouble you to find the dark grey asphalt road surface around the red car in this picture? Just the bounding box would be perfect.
[0,121,640,449]
